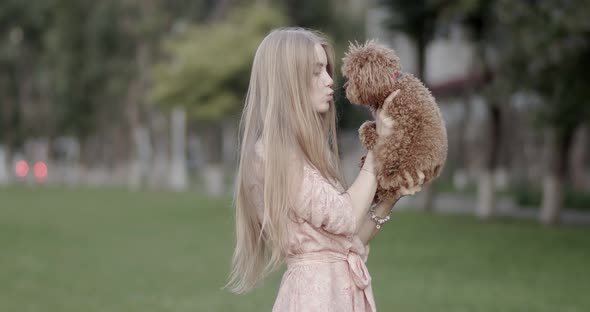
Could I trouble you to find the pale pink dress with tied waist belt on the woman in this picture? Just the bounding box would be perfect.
[255,145,376,312]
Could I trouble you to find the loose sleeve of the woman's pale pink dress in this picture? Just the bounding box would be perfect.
[295,165,356,235]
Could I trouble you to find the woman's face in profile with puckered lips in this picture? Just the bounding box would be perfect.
[311,43,334,113]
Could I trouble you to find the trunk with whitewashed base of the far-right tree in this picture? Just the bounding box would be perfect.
[539,129,574,224]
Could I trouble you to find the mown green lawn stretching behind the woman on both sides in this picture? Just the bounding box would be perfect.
[0,188,590,312]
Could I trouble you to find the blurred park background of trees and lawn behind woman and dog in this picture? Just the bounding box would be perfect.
[0,0,590,312]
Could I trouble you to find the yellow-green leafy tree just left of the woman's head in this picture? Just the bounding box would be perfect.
[151,5,286,193]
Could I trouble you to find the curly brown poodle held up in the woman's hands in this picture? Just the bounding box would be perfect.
[342,40,448,201]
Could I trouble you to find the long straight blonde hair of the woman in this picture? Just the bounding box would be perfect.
[224,28,345,293]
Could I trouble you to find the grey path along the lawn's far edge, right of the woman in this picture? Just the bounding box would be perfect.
[396,193,590,225]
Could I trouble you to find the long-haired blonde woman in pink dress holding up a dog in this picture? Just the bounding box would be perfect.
[226,28,421,312]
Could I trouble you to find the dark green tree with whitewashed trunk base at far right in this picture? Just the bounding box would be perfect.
[499,0,590,224]
